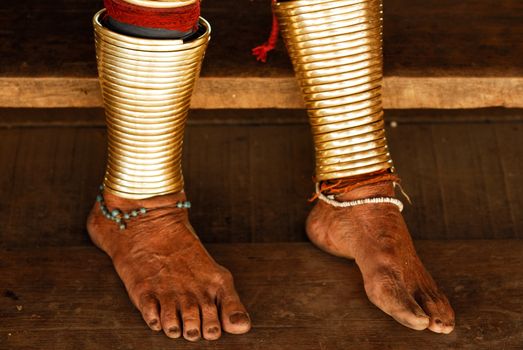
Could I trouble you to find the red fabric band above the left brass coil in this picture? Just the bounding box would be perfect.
[104,0,200,32]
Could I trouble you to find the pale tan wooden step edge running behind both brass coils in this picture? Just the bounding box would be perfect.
[0,76,523,109]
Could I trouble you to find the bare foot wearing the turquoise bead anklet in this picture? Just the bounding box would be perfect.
[87,193,251,341]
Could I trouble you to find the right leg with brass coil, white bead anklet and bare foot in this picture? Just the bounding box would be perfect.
[274,0,454,333]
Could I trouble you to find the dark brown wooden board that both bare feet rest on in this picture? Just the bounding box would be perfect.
[0,240,523,350]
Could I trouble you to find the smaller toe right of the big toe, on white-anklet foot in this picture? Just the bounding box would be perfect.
[419,293,455,334]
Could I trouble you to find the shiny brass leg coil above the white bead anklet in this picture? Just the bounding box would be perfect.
[273,0,393,181]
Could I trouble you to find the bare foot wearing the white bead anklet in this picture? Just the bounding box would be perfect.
[307,182,454,333]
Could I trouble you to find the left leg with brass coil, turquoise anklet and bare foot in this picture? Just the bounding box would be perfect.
[87,0,250,340]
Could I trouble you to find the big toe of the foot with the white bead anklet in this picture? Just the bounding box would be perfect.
[365,276,429,330]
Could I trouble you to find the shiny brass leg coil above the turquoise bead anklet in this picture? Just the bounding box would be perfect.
[93,10,211,199]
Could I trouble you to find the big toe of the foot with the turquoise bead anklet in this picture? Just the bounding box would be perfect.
[219,287,251,334]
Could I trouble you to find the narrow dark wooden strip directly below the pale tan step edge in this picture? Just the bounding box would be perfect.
[0,108,523,128]
